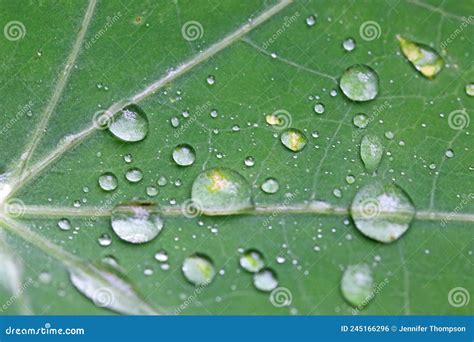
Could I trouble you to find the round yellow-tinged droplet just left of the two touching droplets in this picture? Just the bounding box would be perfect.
[181,254,216,286]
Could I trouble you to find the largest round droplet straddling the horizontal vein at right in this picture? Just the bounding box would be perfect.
[351,182,415,243]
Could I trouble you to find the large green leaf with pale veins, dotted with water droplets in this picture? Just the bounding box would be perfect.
[0,0,474,315]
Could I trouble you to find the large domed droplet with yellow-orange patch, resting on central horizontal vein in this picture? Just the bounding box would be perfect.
[191,167,254,215]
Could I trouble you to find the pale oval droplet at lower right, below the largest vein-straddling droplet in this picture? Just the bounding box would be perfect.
[341,264,374,308]
